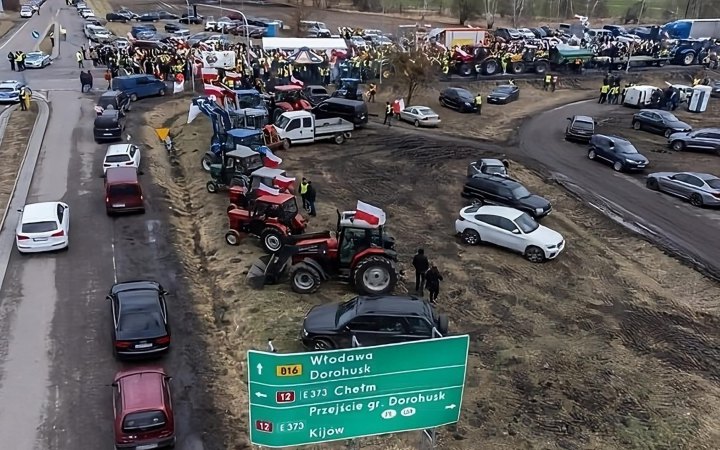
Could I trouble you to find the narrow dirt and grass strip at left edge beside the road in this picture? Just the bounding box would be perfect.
[0,102,38,218]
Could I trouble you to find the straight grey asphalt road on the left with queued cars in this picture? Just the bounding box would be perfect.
[0,0,222,450]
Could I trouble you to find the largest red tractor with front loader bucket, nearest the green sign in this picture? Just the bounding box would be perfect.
[247,211,398,295]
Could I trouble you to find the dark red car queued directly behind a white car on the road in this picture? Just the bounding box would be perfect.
[105,167,145,215]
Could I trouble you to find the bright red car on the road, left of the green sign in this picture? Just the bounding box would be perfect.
[112,367,175,450]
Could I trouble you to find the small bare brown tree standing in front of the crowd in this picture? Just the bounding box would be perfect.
[389,48,438,105]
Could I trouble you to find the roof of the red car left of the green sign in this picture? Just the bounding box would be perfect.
[115,368,166,414]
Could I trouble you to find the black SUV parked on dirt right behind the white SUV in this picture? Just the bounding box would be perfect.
[462,174,552,219]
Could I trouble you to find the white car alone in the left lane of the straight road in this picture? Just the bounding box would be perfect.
[15,202,70,253]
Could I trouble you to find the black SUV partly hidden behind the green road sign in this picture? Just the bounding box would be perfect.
[302,295,448,350]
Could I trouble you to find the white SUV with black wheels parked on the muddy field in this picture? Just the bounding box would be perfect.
[455,205,565,263]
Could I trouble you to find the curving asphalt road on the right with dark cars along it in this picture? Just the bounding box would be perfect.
[508,100,720,278]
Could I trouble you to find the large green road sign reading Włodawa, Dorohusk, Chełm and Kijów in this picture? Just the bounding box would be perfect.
[248,336,470,447]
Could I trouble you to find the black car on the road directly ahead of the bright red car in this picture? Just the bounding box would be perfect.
[106,280,170,358]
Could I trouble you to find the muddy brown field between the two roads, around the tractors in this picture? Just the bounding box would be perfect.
[116,67,720,450]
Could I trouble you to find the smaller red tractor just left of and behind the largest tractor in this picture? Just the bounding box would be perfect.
[225,194,307,253]
